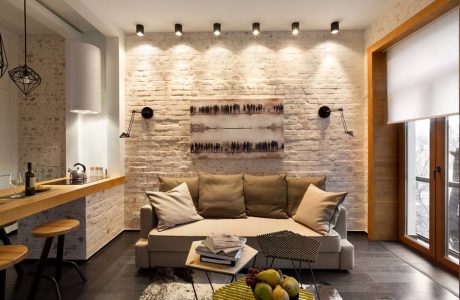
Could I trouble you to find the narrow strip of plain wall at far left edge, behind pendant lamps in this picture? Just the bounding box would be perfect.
[0,27,18,188]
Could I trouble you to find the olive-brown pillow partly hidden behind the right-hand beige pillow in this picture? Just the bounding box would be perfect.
[286,176,326,217]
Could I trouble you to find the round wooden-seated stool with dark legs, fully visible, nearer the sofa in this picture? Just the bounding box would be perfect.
[28,219,86,299]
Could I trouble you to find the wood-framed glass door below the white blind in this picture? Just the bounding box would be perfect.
[400,115,460,271]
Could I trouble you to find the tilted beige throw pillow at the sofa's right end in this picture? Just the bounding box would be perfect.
[294,184,347,235]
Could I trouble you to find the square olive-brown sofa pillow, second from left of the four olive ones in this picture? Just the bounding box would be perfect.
[198,174,246,219]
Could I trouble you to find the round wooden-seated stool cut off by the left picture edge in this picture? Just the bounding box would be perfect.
[0,245,29,300]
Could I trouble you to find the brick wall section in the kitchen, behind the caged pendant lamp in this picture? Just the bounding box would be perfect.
[17,35,66,180]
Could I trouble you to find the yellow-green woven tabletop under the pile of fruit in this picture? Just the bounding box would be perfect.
[212,277,315,300]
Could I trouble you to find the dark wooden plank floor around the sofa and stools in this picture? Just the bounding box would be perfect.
[7,232,458,300]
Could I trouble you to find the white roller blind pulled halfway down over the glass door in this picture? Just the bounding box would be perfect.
[387,8,459,124]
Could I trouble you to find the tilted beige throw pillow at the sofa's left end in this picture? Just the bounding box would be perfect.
[145,182,203,231]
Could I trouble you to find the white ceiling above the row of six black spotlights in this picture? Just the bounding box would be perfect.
[80,0,391,33]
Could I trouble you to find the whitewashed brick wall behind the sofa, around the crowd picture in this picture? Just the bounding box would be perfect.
[125,31,366,230]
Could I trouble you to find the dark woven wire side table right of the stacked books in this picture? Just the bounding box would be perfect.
[257,230,320,299]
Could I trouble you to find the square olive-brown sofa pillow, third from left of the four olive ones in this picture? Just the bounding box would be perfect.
[244,174,288,219]
